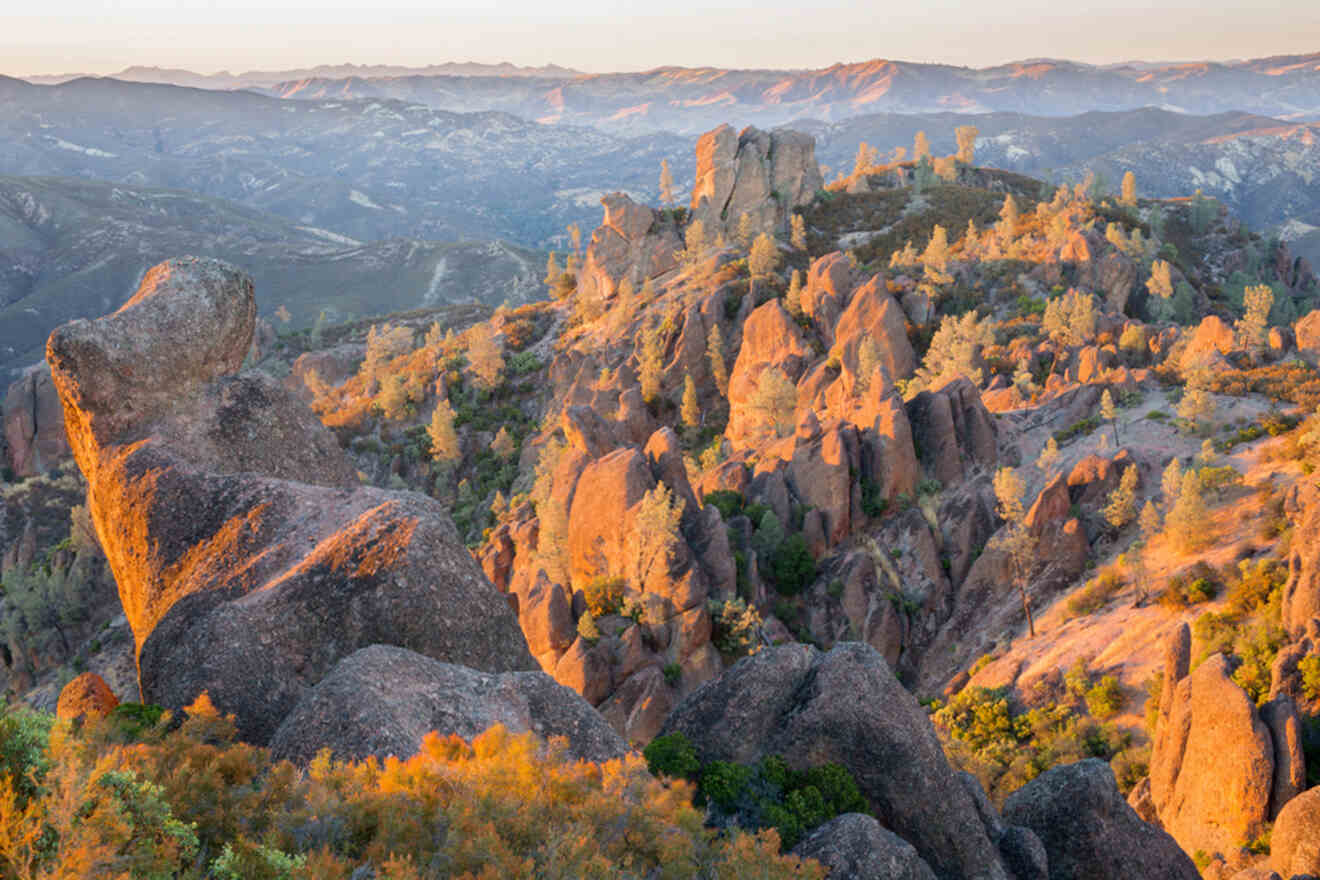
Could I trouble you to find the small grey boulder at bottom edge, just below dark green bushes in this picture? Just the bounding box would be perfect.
[793,813,936,880]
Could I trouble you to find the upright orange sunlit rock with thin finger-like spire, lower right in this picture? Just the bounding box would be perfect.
[1150,623,1305,854]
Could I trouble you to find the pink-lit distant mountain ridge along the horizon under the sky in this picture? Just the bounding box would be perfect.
[15,53,1320,135]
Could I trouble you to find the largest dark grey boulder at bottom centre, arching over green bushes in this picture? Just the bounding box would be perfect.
[661,643,1008,879]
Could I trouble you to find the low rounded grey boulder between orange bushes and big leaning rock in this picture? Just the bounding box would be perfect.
[271,645,628,764]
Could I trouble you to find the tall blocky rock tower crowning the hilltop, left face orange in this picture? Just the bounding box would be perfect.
[692,125,825,237]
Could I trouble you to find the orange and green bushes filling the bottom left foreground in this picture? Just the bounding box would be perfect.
[0,697,818,880]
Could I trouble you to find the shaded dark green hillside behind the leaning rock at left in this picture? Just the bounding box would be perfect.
[0,177,545,375]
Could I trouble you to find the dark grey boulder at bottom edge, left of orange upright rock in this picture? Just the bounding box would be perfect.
[1003,759,1199,880]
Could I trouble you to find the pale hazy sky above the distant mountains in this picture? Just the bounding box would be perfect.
[0,0,1320,74]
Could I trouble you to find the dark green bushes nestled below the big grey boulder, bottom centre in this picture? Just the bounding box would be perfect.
[643,734,869,848]
